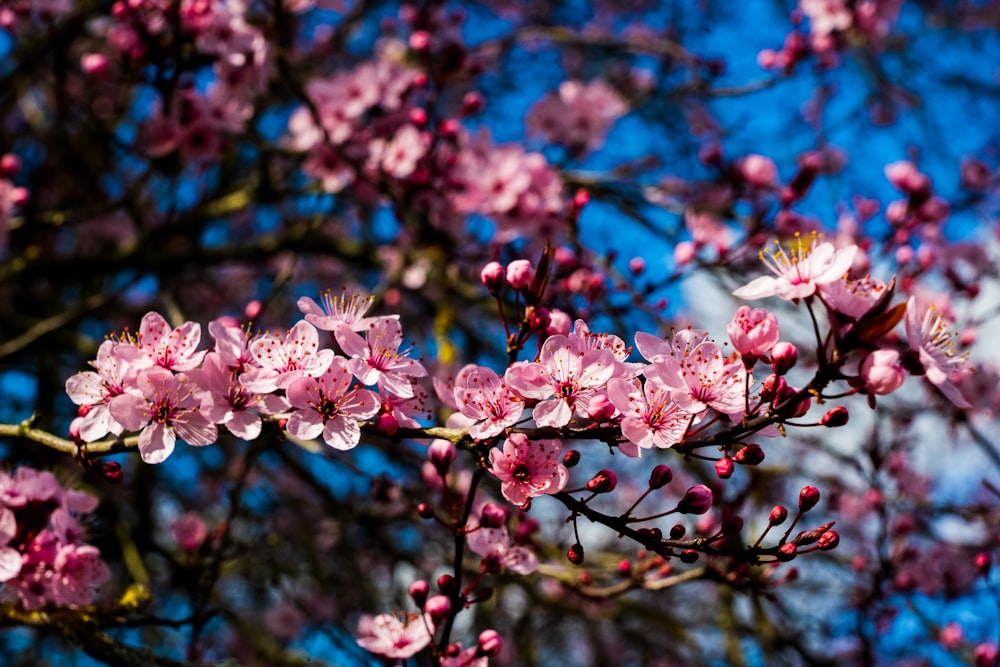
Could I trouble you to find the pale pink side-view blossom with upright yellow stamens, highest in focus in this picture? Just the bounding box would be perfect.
[733,234,858,300]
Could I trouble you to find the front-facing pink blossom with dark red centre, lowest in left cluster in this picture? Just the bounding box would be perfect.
[110,366,218,463]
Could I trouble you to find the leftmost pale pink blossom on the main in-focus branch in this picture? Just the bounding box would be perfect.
[66,340,150,442]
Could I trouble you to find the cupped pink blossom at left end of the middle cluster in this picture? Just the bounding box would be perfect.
[454,364,524,440]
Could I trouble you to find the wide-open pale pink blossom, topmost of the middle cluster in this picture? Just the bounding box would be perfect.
[504,335,616,427]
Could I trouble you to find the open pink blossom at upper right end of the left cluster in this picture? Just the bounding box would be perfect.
[334,317,427,398]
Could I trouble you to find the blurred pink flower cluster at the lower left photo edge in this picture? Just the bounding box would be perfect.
[0,468,110,609]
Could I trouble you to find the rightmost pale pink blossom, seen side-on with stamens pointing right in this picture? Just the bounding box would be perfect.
[906,297,971,408]
